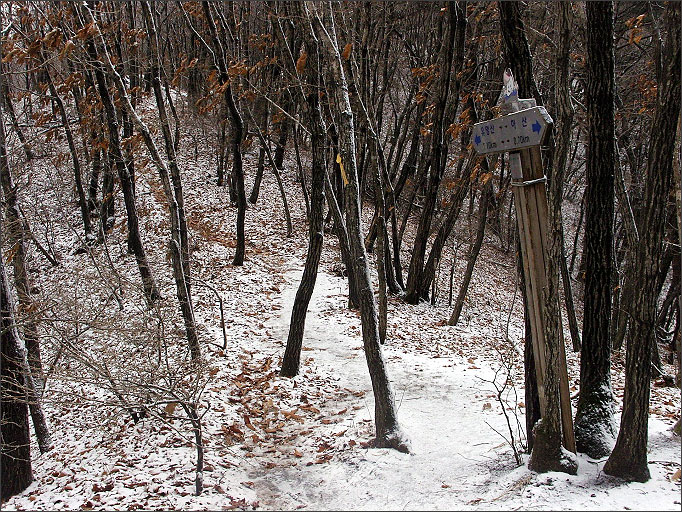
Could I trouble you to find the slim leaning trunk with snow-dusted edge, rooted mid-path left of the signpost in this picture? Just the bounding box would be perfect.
[304,3,409,452]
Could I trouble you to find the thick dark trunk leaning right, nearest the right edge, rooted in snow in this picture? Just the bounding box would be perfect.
[604,2,681,482]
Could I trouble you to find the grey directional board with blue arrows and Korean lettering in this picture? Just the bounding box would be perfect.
[472,107,553,155]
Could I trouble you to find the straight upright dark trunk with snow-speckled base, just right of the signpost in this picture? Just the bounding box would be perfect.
[575,2,616,459]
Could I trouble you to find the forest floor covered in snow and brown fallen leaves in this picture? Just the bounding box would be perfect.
[3,95,680,510]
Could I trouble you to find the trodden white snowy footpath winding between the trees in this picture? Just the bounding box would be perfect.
[244,271,509,510]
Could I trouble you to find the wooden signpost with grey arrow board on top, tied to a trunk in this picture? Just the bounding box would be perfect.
[472,72,576,453]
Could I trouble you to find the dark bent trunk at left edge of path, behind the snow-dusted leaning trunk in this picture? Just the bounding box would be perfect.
[281,26,326,377]
